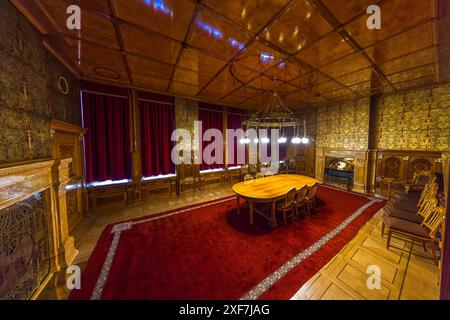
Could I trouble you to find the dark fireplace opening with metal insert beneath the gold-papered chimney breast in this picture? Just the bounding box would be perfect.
[324,157,355,190]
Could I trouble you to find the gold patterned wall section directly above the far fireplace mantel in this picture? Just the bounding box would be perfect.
[316,99,369,150]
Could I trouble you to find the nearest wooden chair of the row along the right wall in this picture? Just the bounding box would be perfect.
[382,207,445,264]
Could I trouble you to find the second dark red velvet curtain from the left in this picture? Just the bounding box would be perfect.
[139,100,175,177]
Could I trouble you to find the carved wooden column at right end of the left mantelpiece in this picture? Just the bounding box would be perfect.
[52,159,78,267]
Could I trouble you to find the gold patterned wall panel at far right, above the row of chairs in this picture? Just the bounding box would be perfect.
[376,85,450,151]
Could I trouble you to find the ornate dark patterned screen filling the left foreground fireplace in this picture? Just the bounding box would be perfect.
[0,194,50,300]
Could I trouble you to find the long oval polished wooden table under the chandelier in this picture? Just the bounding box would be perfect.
[232,174,319,227]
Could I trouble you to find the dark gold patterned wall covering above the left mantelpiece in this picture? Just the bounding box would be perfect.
[0,1,81,164]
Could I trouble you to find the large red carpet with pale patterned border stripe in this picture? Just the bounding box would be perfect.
[70,186,384,299]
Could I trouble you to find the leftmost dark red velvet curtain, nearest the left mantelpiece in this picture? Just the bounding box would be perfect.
[82,92,131,182]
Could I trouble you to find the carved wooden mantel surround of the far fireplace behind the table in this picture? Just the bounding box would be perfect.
[316,148,368,193]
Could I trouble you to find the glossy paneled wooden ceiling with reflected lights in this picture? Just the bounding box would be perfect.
[12,0,450,108]
